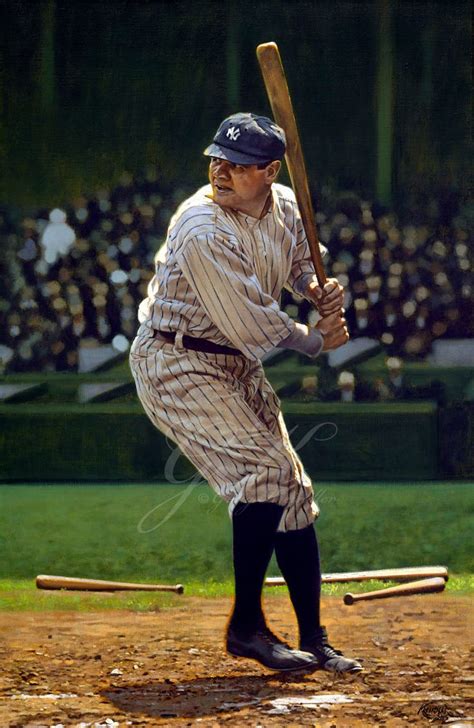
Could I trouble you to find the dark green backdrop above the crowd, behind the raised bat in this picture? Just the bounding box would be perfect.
[0,0,470,208]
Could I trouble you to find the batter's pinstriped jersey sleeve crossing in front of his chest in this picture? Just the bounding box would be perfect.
[176,233,295,359]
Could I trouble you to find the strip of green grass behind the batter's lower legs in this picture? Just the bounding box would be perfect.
[0,482,474,609]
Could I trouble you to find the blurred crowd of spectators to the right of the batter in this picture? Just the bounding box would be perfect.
[286,188,474,359]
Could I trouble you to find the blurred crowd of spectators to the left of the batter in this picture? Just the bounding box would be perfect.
[0,167,189,372]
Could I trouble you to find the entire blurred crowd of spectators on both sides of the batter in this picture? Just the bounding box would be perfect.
[0,167,472,372]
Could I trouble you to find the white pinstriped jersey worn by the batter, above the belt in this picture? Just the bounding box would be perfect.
[139,184,320,359]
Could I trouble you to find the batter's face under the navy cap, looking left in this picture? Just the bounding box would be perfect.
[209,157,281,217]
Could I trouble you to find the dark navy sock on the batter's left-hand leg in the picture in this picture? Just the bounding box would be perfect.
[229,503,283,634]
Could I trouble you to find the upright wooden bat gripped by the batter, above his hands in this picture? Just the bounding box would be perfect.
[257,43,326,287]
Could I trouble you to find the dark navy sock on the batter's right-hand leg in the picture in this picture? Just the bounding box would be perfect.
[275,525,321,641]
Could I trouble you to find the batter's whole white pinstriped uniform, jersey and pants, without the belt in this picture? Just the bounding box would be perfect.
[130,184,318,531]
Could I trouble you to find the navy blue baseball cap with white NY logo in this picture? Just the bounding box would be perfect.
[204,113,286,164]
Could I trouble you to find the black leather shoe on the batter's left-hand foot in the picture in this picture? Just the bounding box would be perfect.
[226,627,319,672]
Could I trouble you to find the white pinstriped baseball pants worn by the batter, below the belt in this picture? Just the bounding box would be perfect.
[130,326,319,531]
